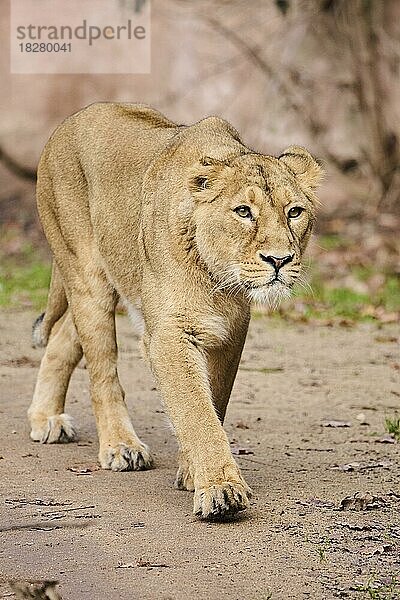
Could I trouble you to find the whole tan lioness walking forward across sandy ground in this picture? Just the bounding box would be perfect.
[28,103,321,519]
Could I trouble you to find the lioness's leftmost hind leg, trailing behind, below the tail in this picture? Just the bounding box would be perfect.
[28,311,82,444]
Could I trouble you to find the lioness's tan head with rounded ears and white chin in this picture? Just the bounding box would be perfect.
[189,148,321,306]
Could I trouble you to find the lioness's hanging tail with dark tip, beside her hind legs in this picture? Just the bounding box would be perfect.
[32,262,68,348]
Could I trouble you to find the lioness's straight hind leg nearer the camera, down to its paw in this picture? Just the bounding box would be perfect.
[62,258,152,471]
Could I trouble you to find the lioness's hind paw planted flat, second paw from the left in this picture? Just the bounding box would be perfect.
[99,443,153,471]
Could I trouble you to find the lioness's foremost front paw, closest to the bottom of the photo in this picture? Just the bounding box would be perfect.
[193,481,251,521]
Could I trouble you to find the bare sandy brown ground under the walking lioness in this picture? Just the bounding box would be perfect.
[0,312,400,600]
